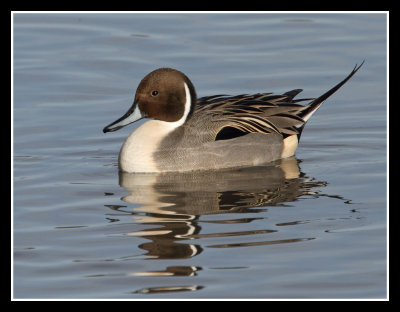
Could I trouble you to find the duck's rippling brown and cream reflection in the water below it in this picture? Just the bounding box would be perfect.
[108,157,332,264]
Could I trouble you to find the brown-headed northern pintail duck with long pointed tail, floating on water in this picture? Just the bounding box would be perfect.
[103,62,364,172]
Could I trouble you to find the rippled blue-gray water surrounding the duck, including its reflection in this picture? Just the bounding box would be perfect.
[12,13,387,299]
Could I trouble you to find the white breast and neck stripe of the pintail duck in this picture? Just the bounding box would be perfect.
[119,83,192,172]
